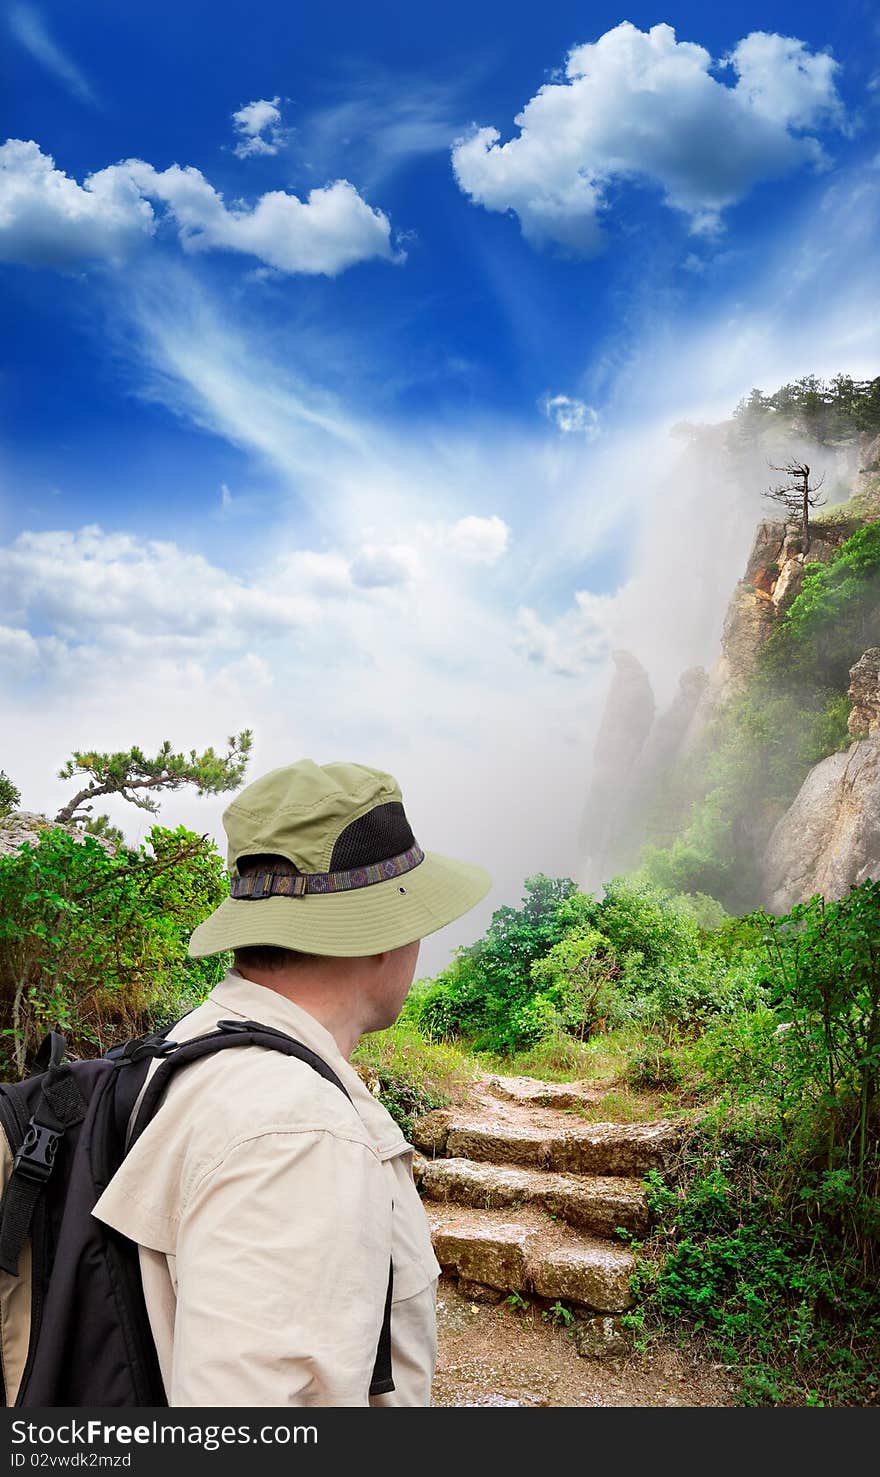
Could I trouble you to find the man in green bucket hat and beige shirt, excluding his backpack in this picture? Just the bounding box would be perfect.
[94,759,490,1406]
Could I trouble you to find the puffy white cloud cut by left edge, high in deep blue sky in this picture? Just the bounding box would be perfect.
[0,139,155,267]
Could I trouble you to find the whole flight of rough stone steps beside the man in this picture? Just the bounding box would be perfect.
[412,1077,681,1340]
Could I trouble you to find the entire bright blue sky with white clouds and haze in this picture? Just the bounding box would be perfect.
[0,0,880,968]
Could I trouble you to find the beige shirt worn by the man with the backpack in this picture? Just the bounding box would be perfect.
[94,970,440,1406]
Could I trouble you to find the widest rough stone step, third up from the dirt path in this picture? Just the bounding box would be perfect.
[412,1109,681,1177]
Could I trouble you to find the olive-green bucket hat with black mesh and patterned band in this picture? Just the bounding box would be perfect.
[189,759,492,959]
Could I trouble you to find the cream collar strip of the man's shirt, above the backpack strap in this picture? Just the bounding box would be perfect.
[207,969,406,1155]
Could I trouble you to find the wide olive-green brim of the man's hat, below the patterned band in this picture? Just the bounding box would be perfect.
[189,851,492,959]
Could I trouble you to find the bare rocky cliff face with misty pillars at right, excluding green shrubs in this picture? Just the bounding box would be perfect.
[579,437,880,913]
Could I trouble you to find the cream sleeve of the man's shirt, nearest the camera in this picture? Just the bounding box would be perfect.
[168,1130,391,1406]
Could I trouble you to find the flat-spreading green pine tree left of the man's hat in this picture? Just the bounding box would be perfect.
[55,728,254,824]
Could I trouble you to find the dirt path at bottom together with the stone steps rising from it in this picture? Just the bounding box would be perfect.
[413,1075,735,1406]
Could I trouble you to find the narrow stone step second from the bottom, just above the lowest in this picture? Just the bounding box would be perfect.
[413,1155,648,1236]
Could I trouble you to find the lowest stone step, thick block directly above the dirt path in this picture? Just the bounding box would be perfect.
[424,1199,635,1313]
